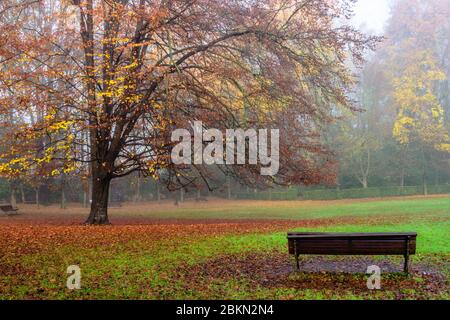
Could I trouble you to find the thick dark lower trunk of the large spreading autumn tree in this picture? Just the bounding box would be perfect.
[85,178,111,225]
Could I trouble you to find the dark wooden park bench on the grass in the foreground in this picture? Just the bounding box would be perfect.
[287,232,417,273]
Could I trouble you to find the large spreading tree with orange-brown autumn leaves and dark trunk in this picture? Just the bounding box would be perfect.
[0,0,376,224]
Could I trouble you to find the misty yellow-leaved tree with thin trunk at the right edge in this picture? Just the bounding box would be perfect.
[392,50,450,194]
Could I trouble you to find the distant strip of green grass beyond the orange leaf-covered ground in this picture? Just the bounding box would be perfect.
[121,196,450,219]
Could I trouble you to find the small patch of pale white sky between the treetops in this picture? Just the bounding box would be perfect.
[352,0,390,35]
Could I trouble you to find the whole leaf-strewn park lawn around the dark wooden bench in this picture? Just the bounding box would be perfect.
[0,197,450,299]
